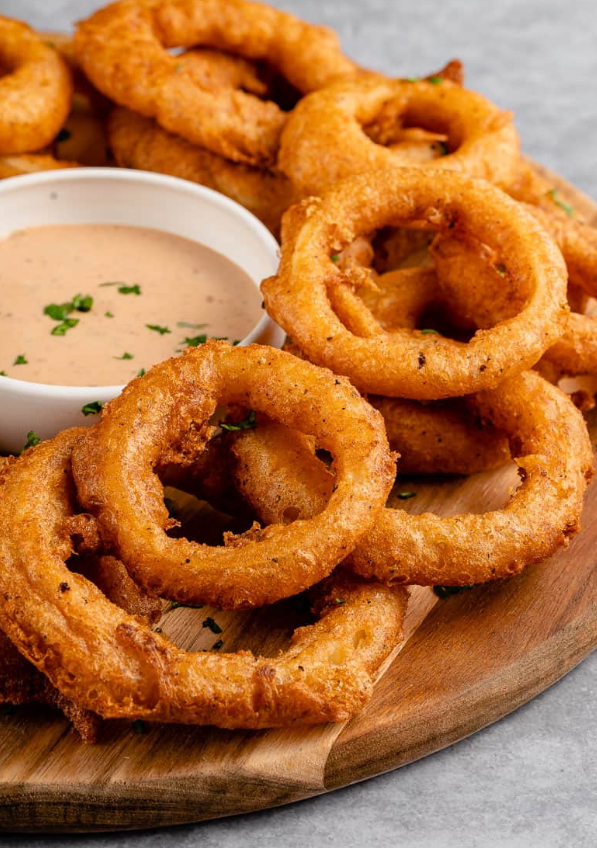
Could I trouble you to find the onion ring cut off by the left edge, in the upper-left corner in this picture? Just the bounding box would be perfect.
[0,16,73,154]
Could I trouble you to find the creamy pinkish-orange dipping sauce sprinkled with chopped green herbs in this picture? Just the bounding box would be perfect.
[0,224,262,386]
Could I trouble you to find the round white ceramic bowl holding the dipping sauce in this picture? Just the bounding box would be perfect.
[0,168,284,453]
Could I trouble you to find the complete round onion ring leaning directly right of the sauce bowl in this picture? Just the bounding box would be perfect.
[262,168,567,400]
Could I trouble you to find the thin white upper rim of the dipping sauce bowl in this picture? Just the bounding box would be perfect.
[0,167,279,401]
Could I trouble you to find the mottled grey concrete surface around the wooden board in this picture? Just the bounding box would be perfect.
[0,0,597,848]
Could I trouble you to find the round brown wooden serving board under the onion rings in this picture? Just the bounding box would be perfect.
[0,164,597,832]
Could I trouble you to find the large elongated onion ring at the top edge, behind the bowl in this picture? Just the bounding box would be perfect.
[75,0,356,165]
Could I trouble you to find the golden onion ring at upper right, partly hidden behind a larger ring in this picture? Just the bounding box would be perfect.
[278,77,519,194]
